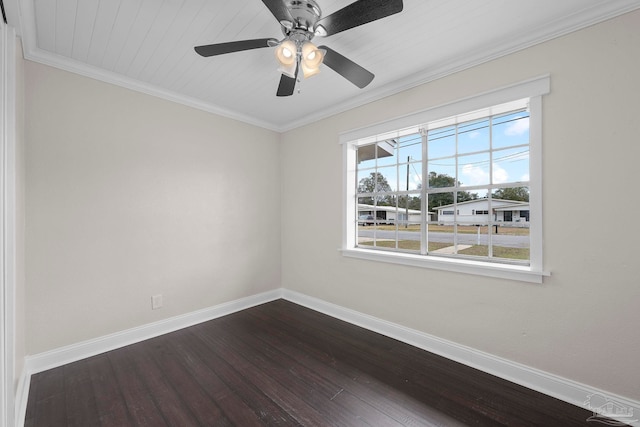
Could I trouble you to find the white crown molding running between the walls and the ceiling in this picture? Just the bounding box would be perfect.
[7,0,640,133]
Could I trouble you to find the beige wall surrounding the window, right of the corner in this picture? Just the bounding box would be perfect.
[282,12,640,399]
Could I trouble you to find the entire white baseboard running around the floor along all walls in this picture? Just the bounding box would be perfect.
[16,289,640,427]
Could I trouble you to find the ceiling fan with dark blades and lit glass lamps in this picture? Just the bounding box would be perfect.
[194,0,403,96]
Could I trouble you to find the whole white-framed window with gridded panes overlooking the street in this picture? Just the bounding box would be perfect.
[341,77,549,282]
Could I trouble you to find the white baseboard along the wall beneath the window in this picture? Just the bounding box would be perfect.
[282,289,640,427]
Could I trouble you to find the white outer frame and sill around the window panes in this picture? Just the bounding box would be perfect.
[340,75,551,283]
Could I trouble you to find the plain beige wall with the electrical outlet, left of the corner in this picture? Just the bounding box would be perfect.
[24,61,280,354]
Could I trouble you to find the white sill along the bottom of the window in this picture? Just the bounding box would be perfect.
[341,248,551,283]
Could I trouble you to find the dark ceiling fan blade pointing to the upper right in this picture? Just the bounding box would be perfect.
[315,0,403,36]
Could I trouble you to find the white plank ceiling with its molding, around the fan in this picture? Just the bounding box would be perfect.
[4,0,640,131]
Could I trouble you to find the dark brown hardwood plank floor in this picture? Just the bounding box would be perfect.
[25,300,604,427]
